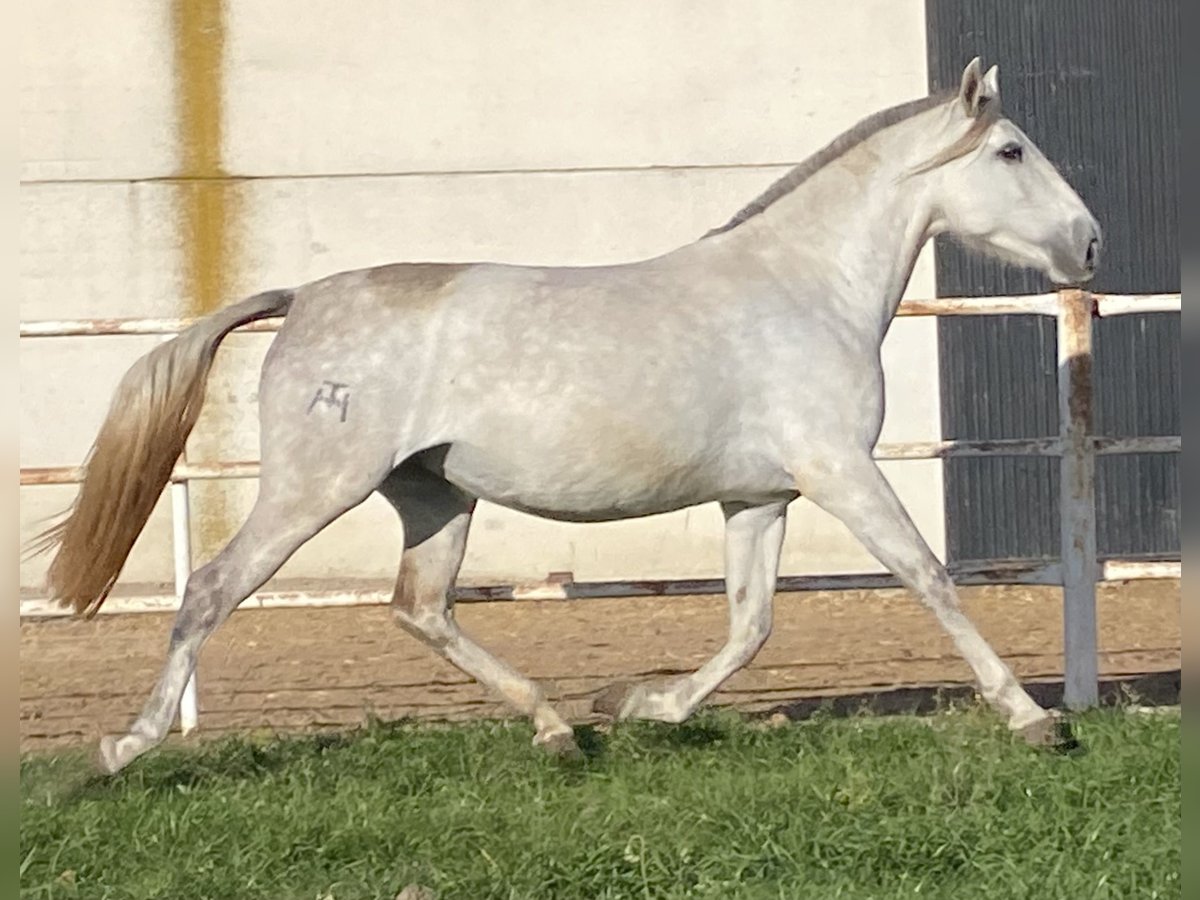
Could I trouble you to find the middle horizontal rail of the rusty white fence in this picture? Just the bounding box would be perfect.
[20,434,1183,486]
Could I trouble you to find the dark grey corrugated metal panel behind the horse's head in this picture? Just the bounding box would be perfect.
[926,0,1181,559]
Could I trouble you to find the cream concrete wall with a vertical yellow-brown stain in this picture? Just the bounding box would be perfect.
[20,0,944,600]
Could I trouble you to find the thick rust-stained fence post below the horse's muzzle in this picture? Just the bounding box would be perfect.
[1058,289,1099,709]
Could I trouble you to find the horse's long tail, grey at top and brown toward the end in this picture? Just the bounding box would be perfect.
[30,290,293,618]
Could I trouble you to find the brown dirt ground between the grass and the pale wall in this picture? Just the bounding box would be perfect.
[20,581,1182,750]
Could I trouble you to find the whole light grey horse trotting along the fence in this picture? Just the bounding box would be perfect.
[38,59,1100,773]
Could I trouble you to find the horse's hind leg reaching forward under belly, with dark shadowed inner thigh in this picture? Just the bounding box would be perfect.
[379,463,577,754]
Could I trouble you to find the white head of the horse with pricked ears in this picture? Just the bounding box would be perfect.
[916,58,1100,284]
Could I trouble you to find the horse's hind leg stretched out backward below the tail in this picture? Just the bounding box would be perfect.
[100,469,378,774]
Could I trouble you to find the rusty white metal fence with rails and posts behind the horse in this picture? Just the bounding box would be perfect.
[20,289,1183,733]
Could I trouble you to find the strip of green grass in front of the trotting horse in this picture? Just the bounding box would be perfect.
[20,710,1181,900]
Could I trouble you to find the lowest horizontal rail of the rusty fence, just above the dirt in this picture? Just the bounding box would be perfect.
[20,559,1183,618]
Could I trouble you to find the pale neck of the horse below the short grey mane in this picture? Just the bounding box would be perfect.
[705,116,930,342]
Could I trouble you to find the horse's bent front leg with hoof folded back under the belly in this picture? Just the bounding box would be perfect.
[594,500,787,722]
